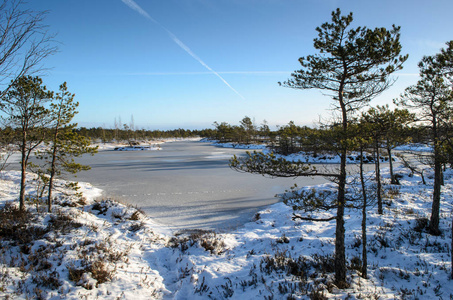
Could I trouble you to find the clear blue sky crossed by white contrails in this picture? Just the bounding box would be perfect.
[27,0,453,129]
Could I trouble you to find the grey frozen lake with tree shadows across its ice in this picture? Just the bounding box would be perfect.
[66,141,325,230]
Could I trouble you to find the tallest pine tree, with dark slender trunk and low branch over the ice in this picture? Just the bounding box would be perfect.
[233,9,407,288]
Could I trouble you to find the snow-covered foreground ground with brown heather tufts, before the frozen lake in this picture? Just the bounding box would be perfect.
[0,155,453,300]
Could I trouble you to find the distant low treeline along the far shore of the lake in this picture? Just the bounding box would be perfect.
[0,117,429,155]
